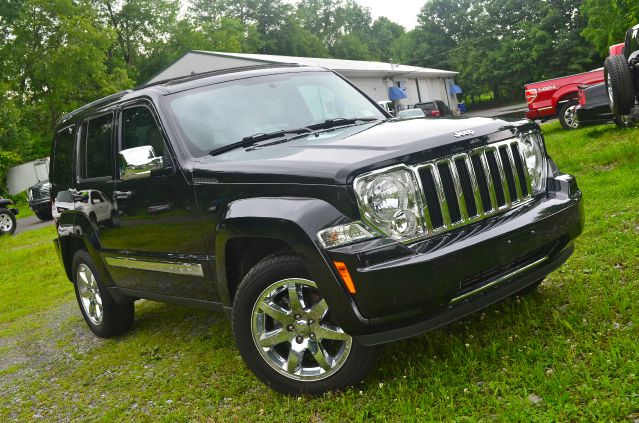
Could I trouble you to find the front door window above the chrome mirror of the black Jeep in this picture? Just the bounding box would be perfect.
[122,106,166,157]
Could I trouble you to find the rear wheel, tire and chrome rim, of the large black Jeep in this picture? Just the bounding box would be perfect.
[72,250,135,338]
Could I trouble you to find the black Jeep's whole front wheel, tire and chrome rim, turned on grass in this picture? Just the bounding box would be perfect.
[233,253,376,395]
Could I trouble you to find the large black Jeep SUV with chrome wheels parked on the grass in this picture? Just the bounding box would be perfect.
[50,65,583,394]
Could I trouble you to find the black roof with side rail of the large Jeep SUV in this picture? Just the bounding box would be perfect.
[58,63,318,127]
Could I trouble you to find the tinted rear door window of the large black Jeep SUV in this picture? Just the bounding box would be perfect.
[79,114,113,179]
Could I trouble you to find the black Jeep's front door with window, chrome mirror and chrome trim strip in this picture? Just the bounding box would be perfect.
[101,102,217,301]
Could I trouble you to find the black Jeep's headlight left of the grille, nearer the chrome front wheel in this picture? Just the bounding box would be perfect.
[355,166,425,240]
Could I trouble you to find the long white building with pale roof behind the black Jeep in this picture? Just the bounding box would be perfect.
[149,51,458,112]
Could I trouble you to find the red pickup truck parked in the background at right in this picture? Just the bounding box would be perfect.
[524,44,623,129]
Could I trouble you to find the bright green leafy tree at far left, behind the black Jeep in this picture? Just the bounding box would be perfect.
[0,0,131,159]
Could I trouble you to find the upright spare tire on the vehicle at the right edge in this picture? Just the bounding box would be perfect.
[604,56,635,116]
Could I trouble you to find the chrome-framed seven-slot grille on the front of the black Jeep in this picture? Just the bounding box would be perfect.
[414,139,532,235]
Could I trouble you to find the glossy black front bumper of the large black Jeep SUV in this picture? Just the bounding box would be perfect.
[329,175,584,345]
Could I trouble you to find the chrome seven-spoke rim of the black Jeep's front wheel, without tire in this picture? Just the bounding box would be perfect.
[251,279,353,382]
